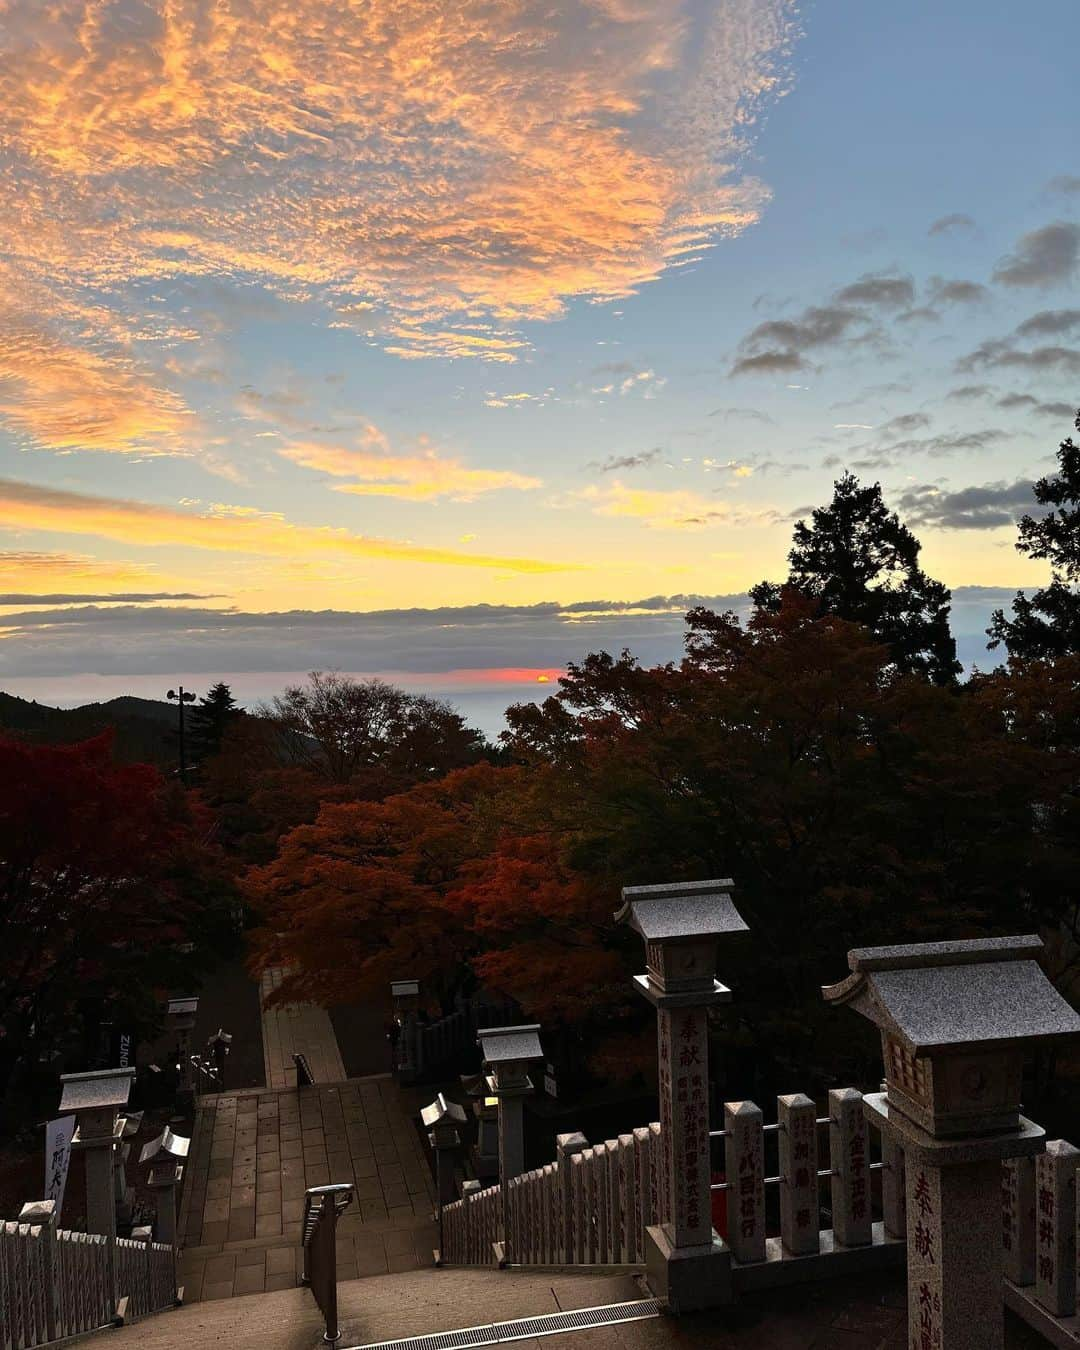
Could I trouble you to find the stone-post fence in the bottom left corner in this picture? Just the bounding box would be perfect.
[0,1202,177,1350]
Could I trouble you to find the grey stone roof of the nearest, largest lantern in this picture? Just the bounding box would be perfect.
[822,936,1080,1054]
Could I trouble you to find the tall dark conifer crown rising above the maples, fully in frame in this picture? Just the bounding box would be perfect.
[751,474,960,684]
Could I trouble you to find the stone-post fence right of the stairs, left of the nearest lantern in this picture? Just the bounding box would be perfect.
[443,1088,905,1288]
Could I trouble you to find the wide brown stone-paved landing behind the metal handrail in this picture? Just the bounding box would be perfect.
[180,1075,436,1301]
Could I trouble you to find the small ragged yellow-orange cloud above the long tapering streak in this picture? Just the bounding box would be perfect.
[278,424,540,502]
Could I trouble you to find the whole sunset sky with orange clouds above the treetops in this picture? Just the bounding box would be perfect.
[0,0,1080,720]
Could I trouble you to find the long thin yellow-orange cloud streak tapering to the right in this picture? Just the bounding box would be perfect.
[0,479,579,572]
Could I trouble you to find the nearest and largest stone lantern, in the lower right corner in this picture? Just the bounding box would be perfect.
[824,937,1080,1350]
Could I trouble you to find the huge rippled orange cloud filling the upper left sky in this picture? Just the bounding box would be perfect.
[0,0,794,452]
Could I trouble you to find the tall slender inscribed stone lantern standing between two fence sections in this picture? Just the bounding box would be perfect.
[616,880,748,1312]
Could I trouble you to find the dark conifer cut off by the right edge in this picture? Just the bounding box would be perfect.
[987,412,1080,660]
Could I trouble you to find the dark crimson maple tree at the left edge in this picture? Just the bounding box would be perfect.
[0,734,230,1111]
